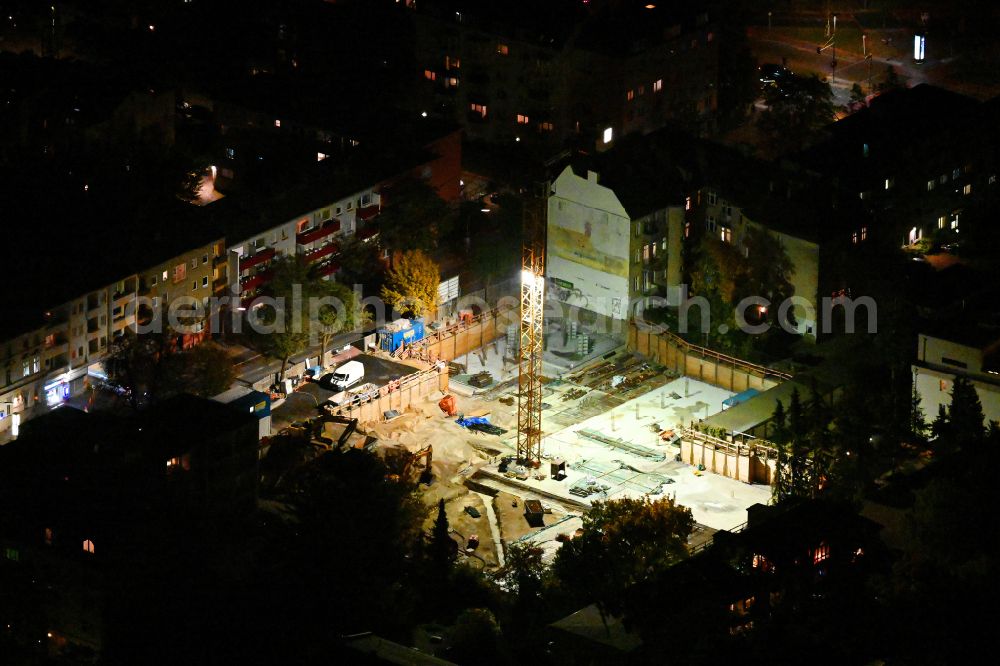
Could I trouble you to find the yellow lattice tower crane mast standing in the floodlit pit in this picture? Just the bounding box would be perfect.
[517,198,545,467]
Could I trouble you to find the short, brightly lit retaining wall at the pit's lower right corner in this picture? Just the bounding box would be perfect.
[681,428,778,485]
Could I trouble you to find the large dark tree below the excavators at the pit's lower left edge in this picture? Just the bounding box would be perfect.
[280,449,424,631]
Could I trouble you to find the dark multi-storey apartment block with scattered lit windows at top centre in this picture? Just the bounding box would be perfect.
[408,0,718,150]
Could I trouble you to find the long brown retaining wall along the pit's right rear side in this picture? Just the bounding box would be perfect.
[628,322,792,393]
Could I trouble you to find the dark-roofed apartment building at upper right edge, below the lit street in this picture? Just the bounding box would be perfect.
[795,84,1000,247]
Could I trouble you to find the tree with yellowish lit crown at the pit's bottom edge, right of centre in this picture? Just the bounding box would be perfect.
[552,498,694,623]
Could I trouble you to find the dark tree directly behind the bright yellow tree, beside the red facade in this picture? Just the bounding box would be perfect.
[378,178,449,252]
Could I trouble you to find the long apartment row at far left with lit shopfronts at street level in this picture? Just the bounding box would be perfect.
[0,201,228,441]
